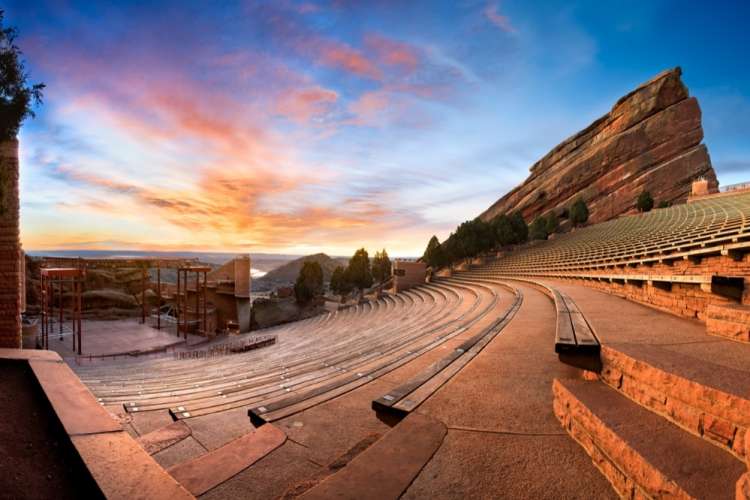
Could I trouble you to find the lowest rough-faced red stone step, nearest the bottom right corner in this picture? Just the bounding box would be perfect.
[553,379,747,499]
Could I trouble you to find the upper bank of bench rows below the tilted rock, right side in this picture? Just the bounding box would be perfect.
[467,192,750,342]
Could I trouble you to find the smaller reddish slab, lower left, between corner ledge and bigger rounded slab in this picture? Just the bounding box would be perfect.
[169,424,286,496]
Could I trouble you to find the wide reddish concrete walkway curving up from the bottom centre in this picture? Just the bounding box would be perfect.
[404,285,616,498]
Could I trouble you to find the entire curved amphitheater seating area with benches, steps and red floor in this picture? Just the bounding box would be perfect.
[0,68,750,500]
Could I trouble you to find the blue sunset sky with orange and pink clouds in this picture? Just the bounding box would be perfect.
[3,0,750,256]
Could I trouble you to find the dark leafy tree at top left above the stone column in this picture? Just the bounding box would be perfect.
[0,10,45,141]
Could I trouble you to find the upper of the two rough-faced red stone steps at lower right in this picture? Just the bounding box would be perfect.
[600,344,750,459]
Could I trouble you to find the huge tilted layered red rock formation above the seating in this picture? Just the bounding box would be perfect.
[480,68,718,222]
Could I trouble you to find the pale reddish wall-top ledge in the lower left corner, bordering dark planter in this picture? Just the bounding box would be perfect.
[0,349,193,500]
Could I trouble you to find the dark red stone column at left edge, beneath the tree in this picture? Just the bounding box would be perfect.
[0,139,21,348]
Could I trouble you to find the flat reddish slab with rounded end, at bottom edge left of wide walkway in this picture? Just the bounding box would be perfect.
[301,413,447,500]
